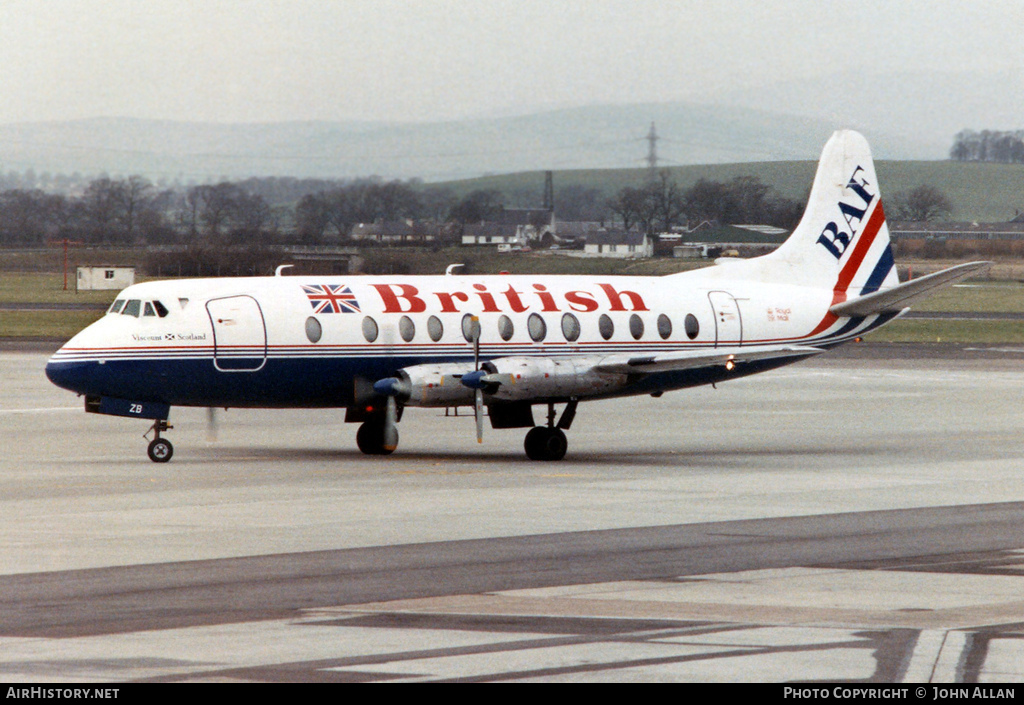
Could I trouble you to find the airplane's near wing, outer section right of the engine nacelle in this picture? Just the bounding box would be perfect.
[597,345,824,374]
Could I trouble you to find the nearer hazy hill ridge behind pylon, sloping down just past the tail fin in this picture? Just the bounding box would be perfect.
[0,102,937,182]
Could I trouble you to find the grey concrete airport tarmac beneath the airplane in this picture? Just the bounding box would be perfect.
[6,345,1024,682]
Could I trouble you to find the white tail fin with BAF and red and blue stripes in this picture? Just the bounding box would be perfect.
[765,130,899,304]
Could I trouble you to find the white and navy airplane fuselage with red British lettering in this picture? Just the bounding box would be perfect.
[44,263,866,407]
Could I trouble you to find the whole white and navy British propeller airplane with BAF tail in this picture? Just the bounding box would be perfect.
[46,130,990,462]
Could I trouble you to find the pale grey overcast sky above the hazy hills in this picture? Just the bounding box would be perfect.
[0,0,1024,122]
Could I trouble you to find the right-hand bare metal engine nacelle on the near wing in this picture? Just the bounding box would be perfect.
[482,358,627,402]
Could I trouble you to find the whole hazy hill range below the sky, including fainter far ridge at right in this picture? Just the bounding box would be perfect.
[0,67,1024,182]
